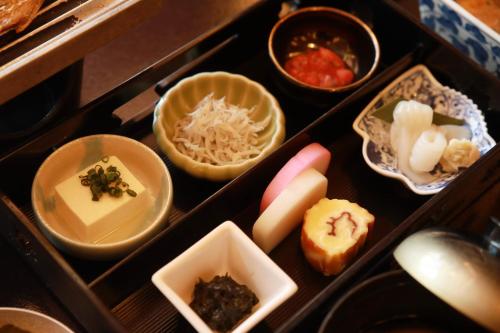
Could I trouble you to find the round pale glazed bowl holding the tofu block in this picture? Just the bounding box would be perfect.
[31,134,173,259]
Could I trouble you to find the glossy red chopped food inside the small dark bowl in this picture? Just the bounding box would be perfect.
[285,47,354,88]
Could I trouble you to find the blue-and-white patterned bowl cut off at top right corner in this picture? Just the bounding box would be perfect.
[419,0,500,77]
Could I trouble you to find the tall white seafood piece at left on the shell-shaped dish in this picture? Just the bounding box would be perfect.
[391,100,434,184]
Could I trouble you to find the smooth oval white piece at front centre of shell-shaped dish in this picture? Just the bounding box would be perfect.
[410,127,446,172]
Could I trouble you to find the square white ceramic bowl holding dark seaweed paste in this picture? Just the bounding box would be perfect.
[152,221,297,332]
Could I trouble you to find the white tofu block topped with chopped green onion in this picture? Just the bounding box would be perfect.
[55,156,149,242]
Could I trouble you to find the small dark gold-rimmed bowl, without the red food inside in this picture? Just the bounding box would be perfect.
[268,7,380,95]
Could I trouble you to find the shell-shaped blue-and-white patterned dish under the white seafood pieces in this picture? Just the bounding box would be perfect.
[353,65,495,195]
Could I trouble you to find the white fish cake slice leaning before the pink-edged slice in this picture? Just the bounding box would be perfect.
[252,168,328,253]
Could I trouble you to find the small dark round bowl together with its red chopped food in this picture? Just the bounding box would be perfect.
[268,7,380,92]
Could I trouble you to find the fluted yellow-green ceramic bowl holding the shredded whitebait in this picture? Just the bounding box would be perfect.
[153,72,285,181]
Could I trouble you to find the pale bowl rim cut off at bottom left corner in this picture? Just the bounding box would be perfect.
[0,307,73,333]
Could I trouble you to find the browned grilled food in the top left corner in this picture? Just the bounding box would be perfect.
[0,0,44,34]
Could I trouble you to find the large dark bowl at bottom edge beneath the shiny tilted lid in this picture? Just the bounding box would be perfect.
[319,270,487,333]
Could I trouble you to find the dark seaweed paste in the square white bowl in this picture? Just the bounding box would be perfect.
[190,274,259,332]
